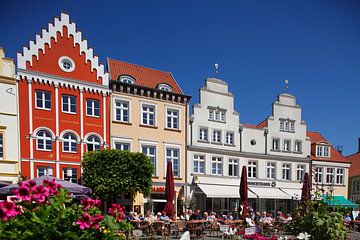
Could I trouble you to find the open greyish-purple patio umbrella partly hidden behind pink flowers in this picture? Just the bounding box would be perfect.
[0,175,91,196]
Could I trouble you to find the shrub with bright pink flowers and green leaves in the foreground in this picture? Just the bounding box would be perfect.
[0,179,131,239]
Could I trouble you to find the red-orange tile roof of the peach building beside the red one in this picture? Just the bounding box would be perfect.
[108,58,183,94]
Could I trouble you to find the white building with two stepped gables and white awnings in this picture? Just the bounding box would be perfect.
[186,78,310,215]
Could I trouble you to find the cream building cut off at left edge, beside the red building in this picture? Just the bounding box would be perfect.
[0,48,19,183]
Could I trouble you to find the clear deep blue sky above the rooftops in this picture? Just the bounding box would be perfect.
[0,0,360,154]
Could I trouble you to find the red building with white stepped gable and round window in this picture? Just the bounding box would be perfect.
[17,13,110,182]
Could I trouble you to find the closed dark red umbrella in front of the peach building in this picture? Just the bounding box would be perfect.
[164,161,175,218]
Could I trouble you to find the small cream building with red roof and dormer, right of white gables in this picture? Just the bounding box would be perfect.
[307,132,351,198]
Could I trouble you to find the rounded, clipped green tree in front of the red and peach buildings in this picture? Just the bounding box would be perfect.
[82,149,154,202]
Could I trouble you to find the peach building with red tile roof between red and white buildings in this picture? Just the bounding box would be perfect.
[108,59,190,212]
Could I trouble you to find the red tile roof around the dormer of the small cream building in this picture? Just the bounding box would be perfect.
[306,131,351,163]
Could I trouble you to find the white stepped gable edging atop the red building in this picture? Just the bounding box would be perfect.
[17,13,109,85]
